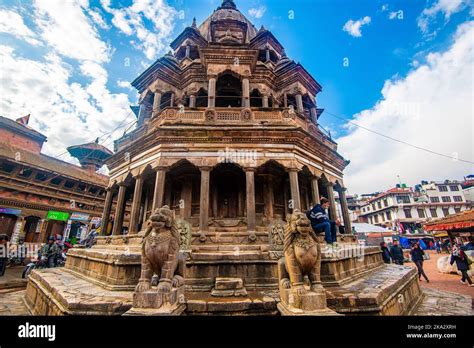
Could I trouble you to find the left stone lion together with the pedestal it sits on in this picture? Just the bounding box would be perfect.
[125,206,186,315]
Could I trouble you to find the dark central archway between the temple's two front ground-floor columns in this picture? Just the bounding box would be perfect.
[211,163,245,219]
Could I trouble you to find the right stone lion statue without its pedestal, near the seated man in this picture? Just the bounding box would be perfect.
[278,209,324,302]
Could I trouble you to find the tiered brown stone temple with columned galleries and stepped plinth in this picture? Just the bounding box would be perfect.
[25,0,470,315]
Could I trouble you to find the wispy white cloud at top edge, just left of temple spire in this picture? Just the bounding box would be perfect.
[102,0,179,60]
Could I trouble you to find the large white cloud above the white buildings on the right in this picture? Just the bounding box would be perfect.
[337,22,474,193]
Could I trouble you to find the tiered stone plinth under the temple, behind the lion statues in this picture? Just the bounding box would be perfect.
[25,237,470,315]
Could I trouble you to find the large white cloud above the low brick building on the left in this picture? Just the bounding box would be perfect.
[0,46,134,159]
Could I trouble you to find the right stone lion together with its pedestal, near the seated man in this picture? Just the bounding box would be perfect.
[278,209,338,315]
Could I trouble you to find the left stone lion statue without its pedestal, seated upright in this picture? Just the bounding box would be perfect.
[135,206,185,295]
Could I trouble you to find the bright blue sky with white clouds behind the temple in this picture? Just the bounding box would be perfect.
[0,0,474,191]
